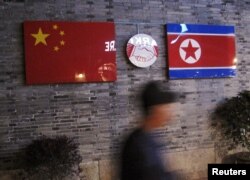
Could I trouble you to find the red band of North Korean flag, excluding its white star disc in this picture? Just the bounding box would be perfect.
[167,35,235,68]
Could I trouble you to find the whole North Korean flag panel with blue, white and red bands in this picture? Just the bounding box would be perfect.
[166,24,237,79]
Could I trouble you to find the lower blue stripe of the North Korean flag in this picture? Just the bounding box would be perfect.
[169,68,236,79]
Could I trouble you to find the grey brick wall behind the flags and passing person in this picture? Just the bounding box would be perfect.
[0,0,250,179]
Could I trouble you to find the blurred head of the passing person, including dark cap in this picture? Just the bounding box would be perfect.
[141,81,178,127]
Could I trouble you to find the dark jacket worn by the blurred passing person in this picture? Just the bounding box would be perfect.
[121,129,172,180]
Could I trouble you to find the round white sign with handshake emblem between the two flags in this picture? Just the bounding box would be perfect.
[126,34,158,68]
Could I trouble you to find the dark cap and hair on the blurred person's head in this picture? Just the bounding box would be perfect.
[141,81,178,115]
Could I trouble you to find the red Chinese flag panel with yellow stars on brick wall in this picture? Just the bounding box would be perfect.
[24,21,116,84]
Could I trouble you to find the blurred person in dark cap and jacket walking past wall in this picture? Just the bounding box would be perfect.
[121,81,177,180]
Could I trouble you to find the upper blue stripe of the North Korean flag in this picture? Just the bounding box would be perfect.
[166,23,235,34]
